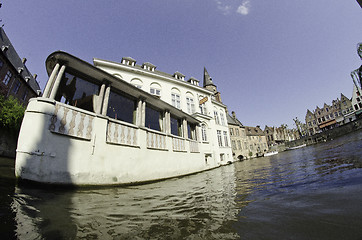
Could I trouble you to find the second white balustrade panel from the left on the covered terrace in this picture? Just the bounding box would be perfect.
[107,121,138,146]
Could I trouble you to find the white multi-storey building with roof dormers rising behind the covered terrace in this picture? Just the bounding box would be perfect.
[93,57,233,164]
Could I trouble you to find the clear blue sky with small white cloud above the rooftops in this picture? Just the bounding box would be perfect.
[0,0,362,128]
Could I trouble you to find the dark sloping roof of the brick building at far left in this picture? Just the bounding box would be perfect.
[0,27,40,93]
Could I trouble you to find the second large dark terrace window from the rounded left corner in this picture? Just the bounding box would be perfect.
[107,89,136,123]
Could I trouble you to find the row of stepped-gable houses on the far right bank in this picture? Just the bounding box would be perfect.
[305,84,362,136]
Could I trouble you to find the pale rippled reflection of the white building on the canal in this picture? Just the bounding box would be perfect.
[13,166,238,239]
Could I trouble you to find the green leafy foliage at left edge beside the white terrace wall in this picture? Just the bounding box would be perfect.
[0,95,25,130]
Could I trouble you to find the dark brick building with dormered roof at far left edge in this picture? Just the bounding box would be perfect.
[0,27,41,106]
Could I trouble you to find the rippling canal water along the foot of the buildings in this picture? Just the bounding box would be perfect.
[0,131,362,240]
